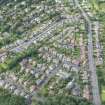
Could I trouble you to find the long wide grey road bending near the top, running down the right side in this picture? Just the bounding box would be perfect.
[74,0,101,105]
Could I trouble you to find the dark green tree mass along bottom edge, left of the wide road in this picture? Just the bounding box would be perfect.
[32,95,92,105]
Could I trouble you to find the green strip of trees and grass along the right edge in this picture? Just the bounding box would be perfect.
[96,4,105,105]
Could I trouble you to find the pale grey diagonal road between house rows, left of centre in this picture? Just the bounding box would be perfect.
[0,20,63,60]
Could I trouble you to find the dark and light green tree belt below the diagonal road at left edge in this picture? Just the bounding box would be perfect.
[0,46,38,71]
